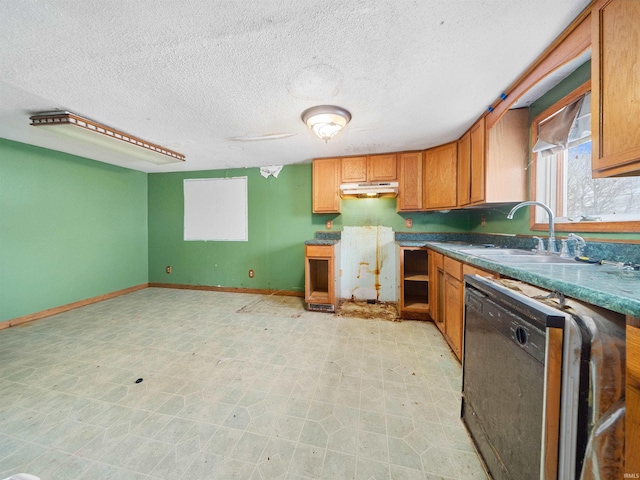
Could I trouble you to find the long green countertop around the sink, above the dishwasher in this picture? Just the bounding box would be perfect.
[397,239,640,317]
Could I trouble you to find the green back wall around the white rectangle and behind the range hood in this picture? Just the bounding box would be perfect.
[149,164,469,292]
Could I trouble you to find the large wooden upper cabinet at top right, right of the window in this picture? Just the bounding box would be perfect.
[591,0,640,177]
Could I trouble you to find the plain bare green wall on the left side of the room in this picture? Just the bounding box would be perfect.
[0,139,148,321]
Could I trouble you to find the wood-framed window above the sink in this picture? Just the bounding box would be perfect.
[531,84,640,232]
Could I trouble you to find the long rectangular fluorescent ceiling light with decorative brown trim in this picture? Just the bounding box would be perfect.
[29,111,185,165]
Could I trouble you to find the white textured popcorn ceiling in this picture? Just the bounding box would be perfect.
[0,0,589,172]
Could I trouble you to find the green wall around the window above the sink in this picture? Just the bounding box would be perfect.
[469,61,640,240]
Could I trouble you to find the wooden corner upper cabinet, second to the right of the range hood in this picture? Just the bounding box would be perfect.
[422,142,458,210]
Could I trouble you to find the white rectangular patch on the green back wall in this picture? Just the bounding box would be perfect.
[184,177,249,242]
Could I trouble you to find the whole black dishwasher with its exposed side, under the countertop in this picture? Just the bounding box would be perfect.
[462,275,626,480]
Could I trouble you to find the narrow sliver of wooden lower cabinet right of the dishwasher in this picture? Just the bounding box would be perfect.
[624,317,640,472]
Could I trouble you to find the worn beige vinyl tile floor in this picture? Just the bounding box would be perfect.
[0,288,487,480]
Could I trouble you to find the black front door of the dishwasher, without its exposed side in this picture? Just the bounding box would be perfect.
[462,275,565,480]
